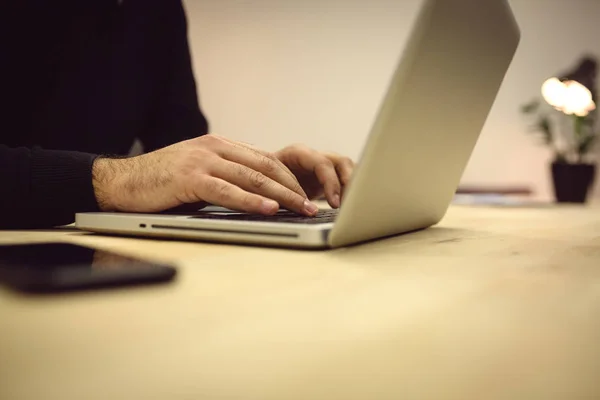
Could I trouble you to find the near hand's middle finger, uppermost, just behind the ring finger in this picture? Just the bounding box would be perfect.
[212,141,307,198]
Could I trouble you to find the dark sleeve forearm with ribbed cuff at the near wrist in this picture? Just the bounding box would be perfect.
[0,145,98,229]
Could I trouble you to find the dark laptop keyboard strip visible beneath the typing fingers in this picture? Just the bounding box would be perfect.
[190,209,338,224]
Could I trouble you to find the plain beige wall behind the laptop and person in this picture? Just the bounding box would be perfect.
[186,0,600,200]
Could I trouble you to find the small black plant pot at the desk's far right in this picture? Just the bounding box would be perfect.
[552,162,596,203]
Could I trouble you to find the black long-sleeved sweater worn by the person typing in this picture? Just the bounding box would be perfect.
[0,0,208,228]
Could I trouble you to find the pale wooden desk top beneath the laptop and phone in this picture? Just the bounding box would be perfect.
[0,206,600,400]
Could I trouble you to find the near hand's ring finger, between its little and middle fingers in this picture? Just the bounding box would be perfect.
[211,159,318,216]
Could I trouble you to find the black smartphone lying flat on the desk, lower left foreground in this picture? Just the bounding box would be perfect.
[0,243,176,292]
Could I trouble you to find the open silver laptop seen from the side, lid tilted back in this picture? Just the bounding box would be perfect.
[76,0,520,248]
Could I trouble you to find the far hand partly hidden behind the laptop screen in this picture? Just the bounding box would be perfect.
[275,145,354,208]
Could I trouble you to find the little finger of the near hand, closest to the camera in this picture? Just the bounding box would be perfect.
[194,175,279,215]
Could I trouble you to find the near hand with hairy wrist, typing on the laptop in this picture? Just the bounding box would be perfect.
[92,135,318,216]
